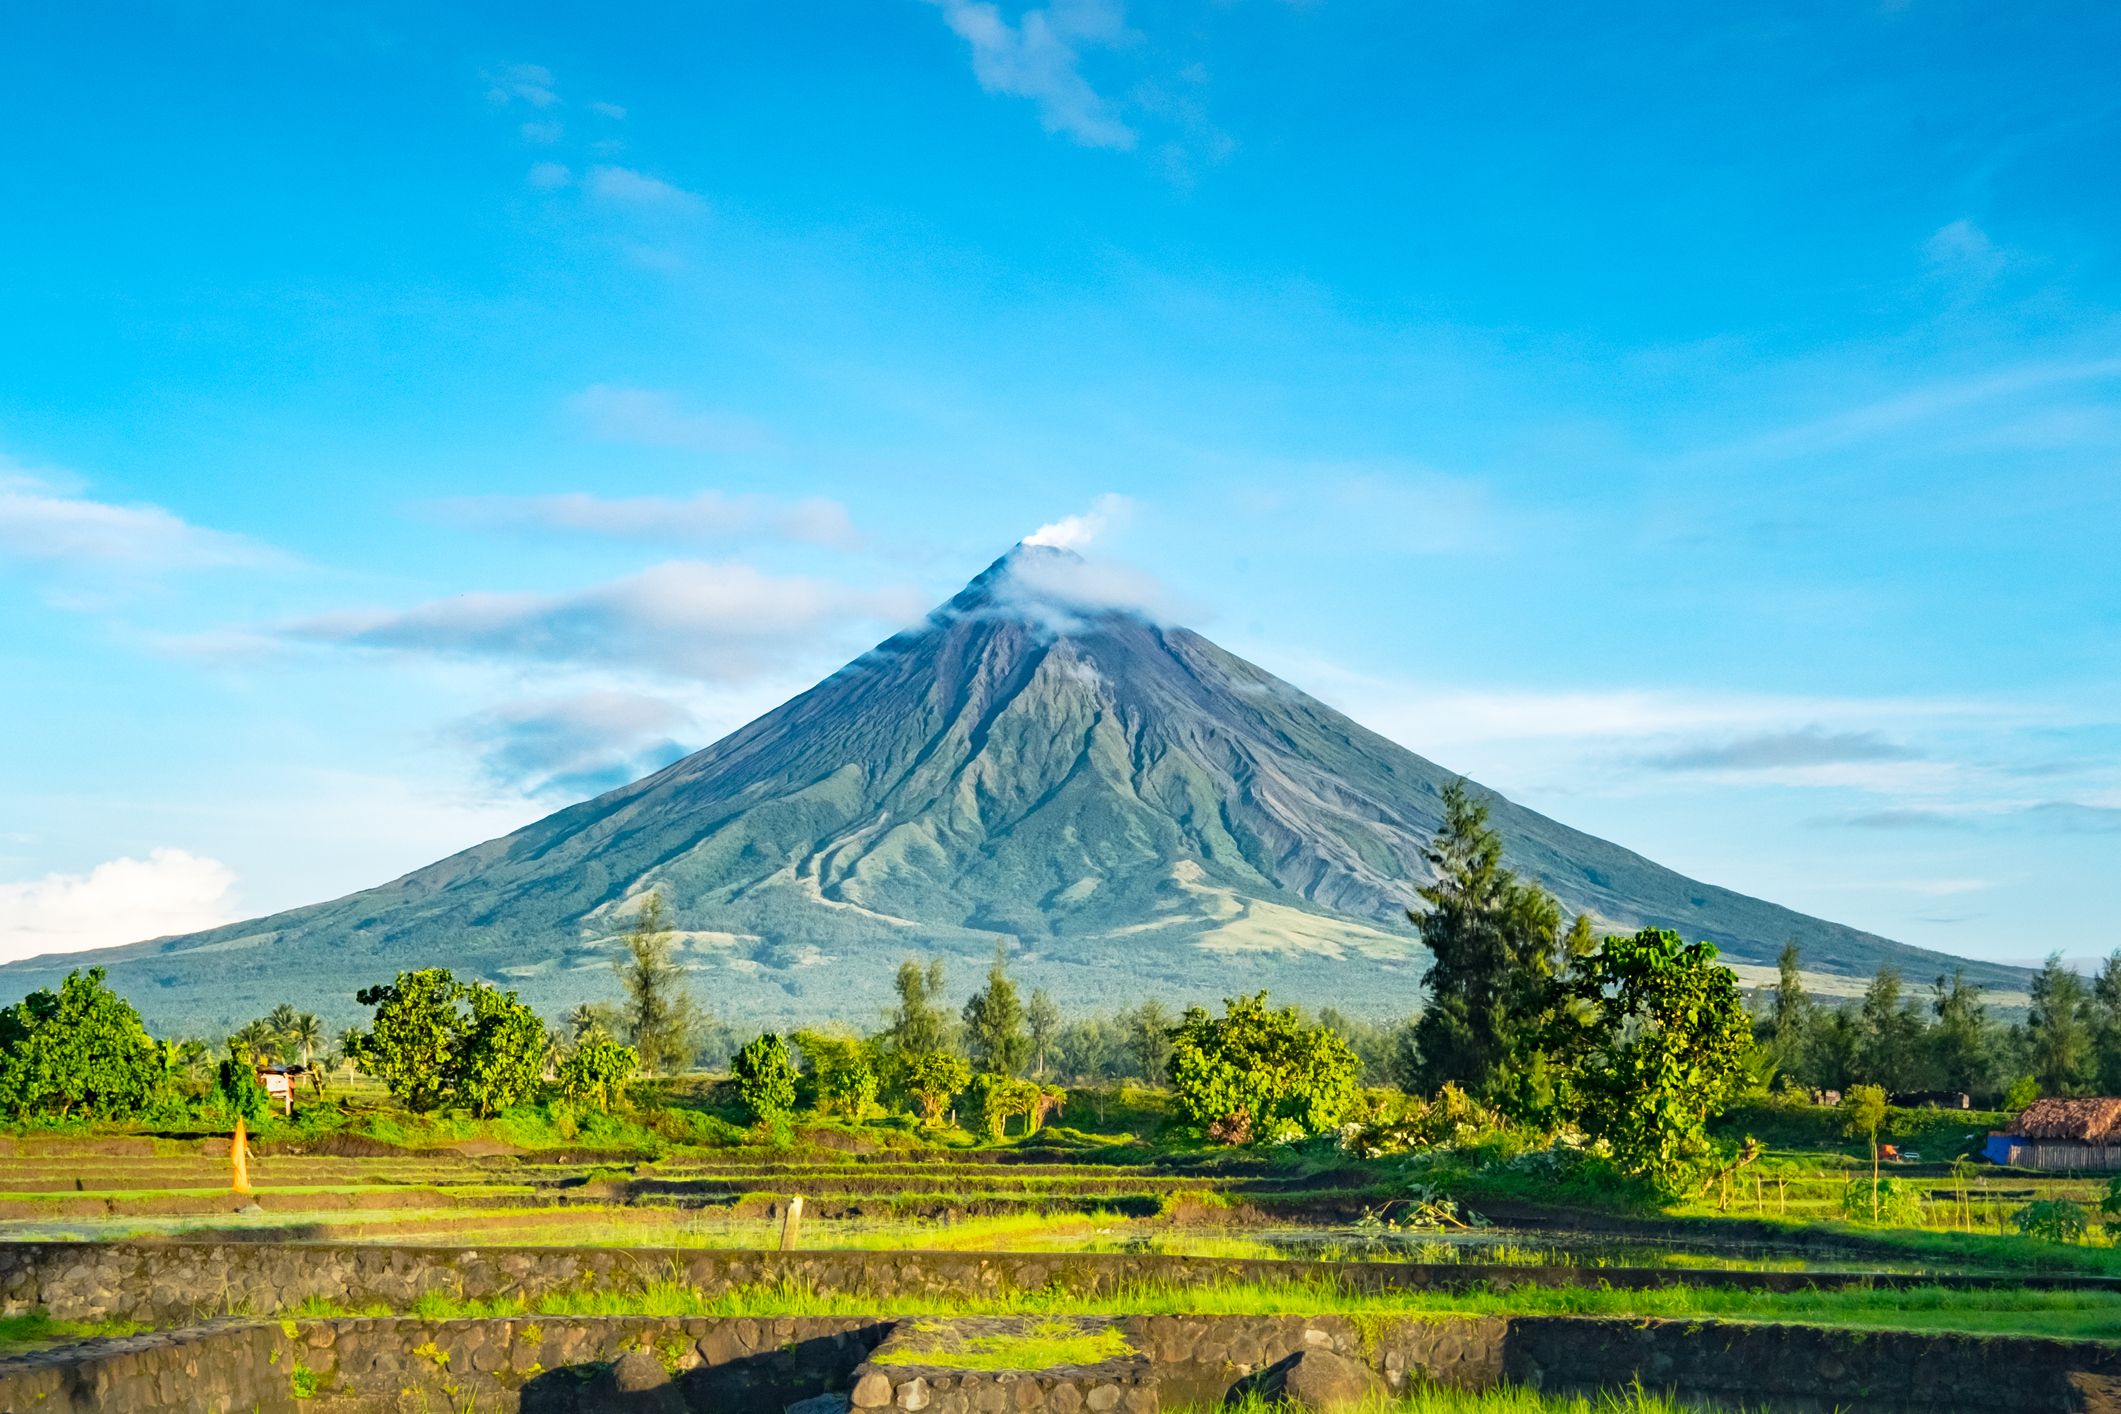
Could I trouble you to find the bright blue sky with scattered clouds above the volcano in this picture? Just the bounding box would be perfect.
[0,0,2121,975]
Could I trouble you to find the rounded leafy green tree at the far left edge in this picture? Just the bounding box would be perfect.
[0,967,168,1119]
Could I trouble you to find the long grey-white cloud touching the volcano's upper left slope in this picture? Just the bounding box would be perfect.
[269,560,921,683]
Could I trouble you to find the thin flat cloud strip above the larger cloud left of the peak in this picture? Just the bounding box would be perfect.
[435,492,861,549]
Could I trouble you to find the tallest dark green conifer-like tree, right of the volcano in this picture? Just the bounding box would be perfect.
[1406,780,1561,1102]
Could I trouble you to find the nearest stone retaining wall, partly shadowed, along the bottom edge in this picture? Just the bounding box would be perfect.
[0,1316,2121,1414]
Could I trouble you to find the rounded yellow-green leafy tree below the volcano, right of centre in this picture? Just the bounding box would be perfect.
[1171,992,1362,1143]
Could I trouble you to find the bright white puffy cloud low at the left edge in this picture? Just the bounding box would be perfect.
[0,850,238,962]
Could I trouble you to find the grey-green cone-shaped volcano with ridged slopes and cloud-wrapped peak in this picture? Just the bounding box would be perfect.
[0,547,2023,1028]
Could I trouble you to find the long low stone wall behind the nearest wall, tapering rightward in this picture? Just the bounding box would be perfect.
[0,1242,2115,1325]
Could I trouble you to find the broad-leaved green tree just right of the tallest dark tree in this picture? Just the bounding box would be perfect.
[1559,929,1752,1191]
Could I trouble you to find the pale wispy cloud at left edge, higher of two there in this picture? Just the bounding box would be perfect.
[0,456,286,572]
